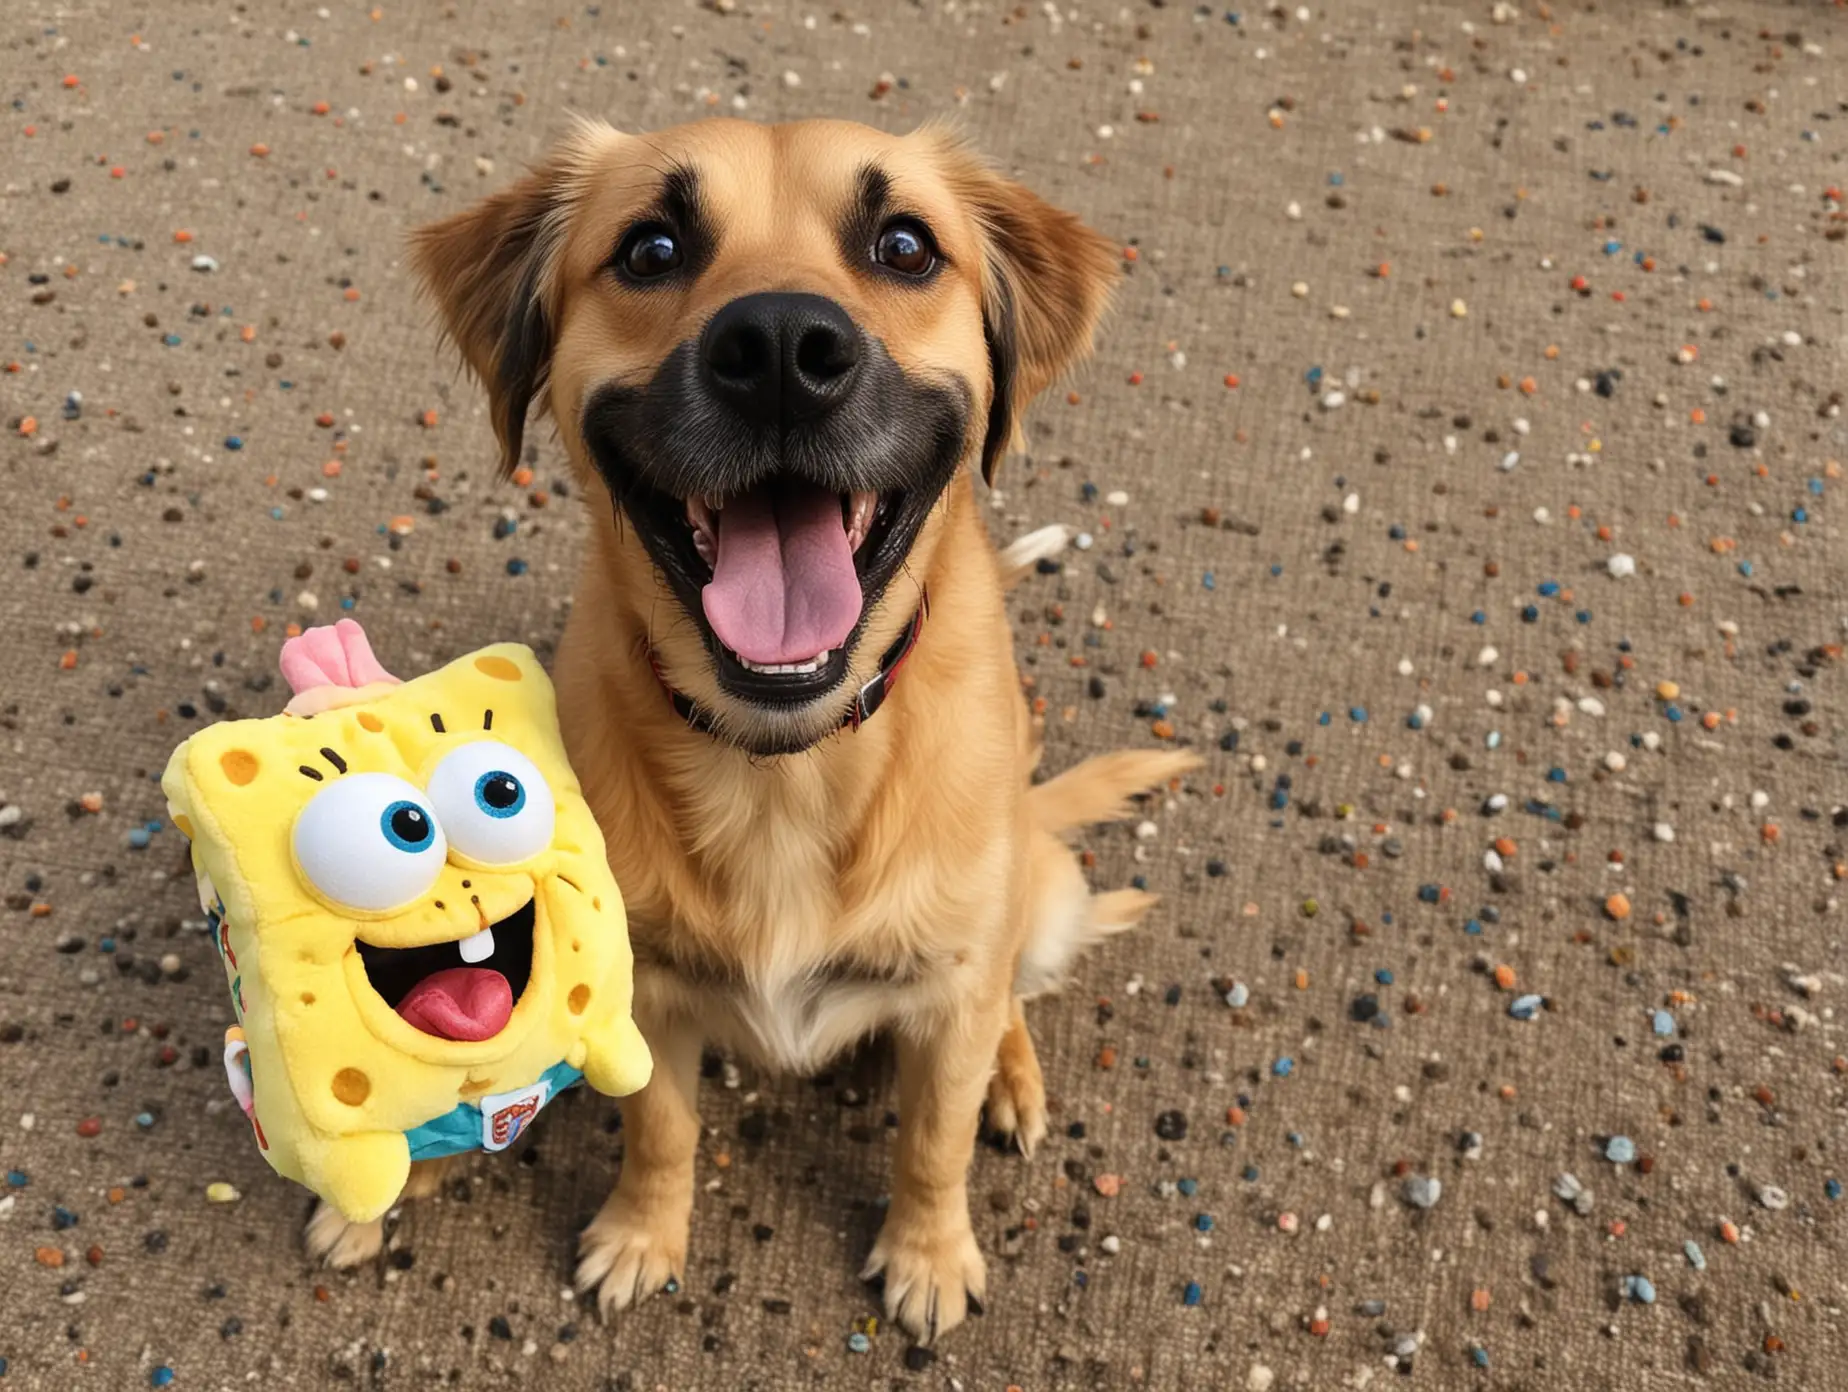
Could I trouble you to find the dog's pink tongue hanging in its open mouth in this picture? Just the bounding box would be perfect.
[702,486,859,664]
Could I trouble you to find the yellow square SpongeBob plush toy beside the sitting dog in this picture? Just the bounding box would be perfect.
[161,619,650,1222]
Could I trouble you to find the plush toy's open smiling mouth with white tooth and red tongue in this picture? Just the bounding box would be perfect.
[359,898,538,1043]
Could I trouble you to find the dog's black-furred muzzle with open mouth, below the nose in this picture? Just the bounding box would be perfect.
[578,329,970,709]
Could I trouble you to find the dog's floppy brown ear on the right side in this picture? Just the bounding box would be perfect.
[933,131,1122,482]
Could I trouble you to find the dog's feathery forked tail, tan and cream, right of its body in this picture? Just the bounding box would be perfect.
[1015,749,1199,998]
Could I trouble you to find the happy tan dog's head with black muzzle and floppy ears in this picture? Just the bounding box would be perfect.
[414,120,1118,752]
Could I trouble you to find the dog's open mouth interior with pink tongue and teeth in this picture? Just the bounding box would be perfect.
[625,473,915,702]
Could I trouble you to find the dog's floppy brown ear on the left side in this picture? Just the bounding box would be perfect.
[410,163,564,473]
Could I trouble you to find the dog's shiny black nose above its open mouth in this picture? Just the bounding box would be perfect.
[700,294,859,429]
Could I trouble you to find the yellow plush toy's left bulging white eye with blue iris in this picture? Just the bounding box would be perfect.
[294,773,447,913]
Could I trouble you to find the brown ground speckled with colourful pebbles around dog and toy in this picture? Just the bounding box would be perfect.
[0,0,1848,1388]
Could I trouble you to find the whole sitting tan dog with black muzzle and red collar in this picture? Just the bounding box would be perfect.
[310,120,1194,1340]
